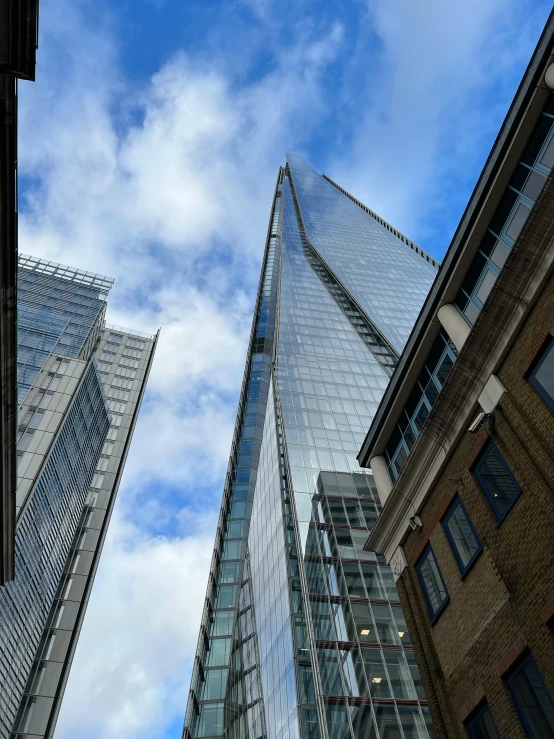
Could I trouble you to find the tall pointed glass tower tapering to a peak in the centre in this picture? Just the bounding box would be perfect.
[183,155,438,739]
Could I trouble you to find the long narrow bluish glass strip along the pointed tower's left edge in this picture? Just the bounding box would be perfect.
[187,182,281,739]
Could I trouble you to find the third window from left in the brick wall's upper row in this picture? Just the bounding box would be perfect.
[473,440,521,521]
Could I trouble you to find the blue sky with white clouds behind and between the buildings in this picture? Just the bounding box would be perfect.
[19,0,550,739]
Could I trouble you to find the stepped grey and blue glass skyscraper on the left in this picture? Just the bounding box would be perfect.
[0,256,157,739]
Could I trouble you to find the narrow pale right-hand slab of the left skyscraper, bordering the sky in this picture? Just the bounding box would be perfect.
[12,328,157,739]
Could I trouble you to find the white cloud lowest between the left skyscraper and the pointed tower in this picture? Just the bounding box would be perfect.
[56,515,215,739]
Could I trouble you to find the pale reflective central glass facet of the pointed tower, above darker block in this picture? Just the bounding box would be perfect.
[277,178,388,516]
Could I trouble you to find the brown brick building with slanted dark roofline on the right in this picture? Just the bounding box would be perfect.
[358,16,554,739]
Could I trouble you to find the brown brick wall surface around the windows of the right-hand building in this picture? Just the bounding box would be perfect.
[399,278,554,739]
